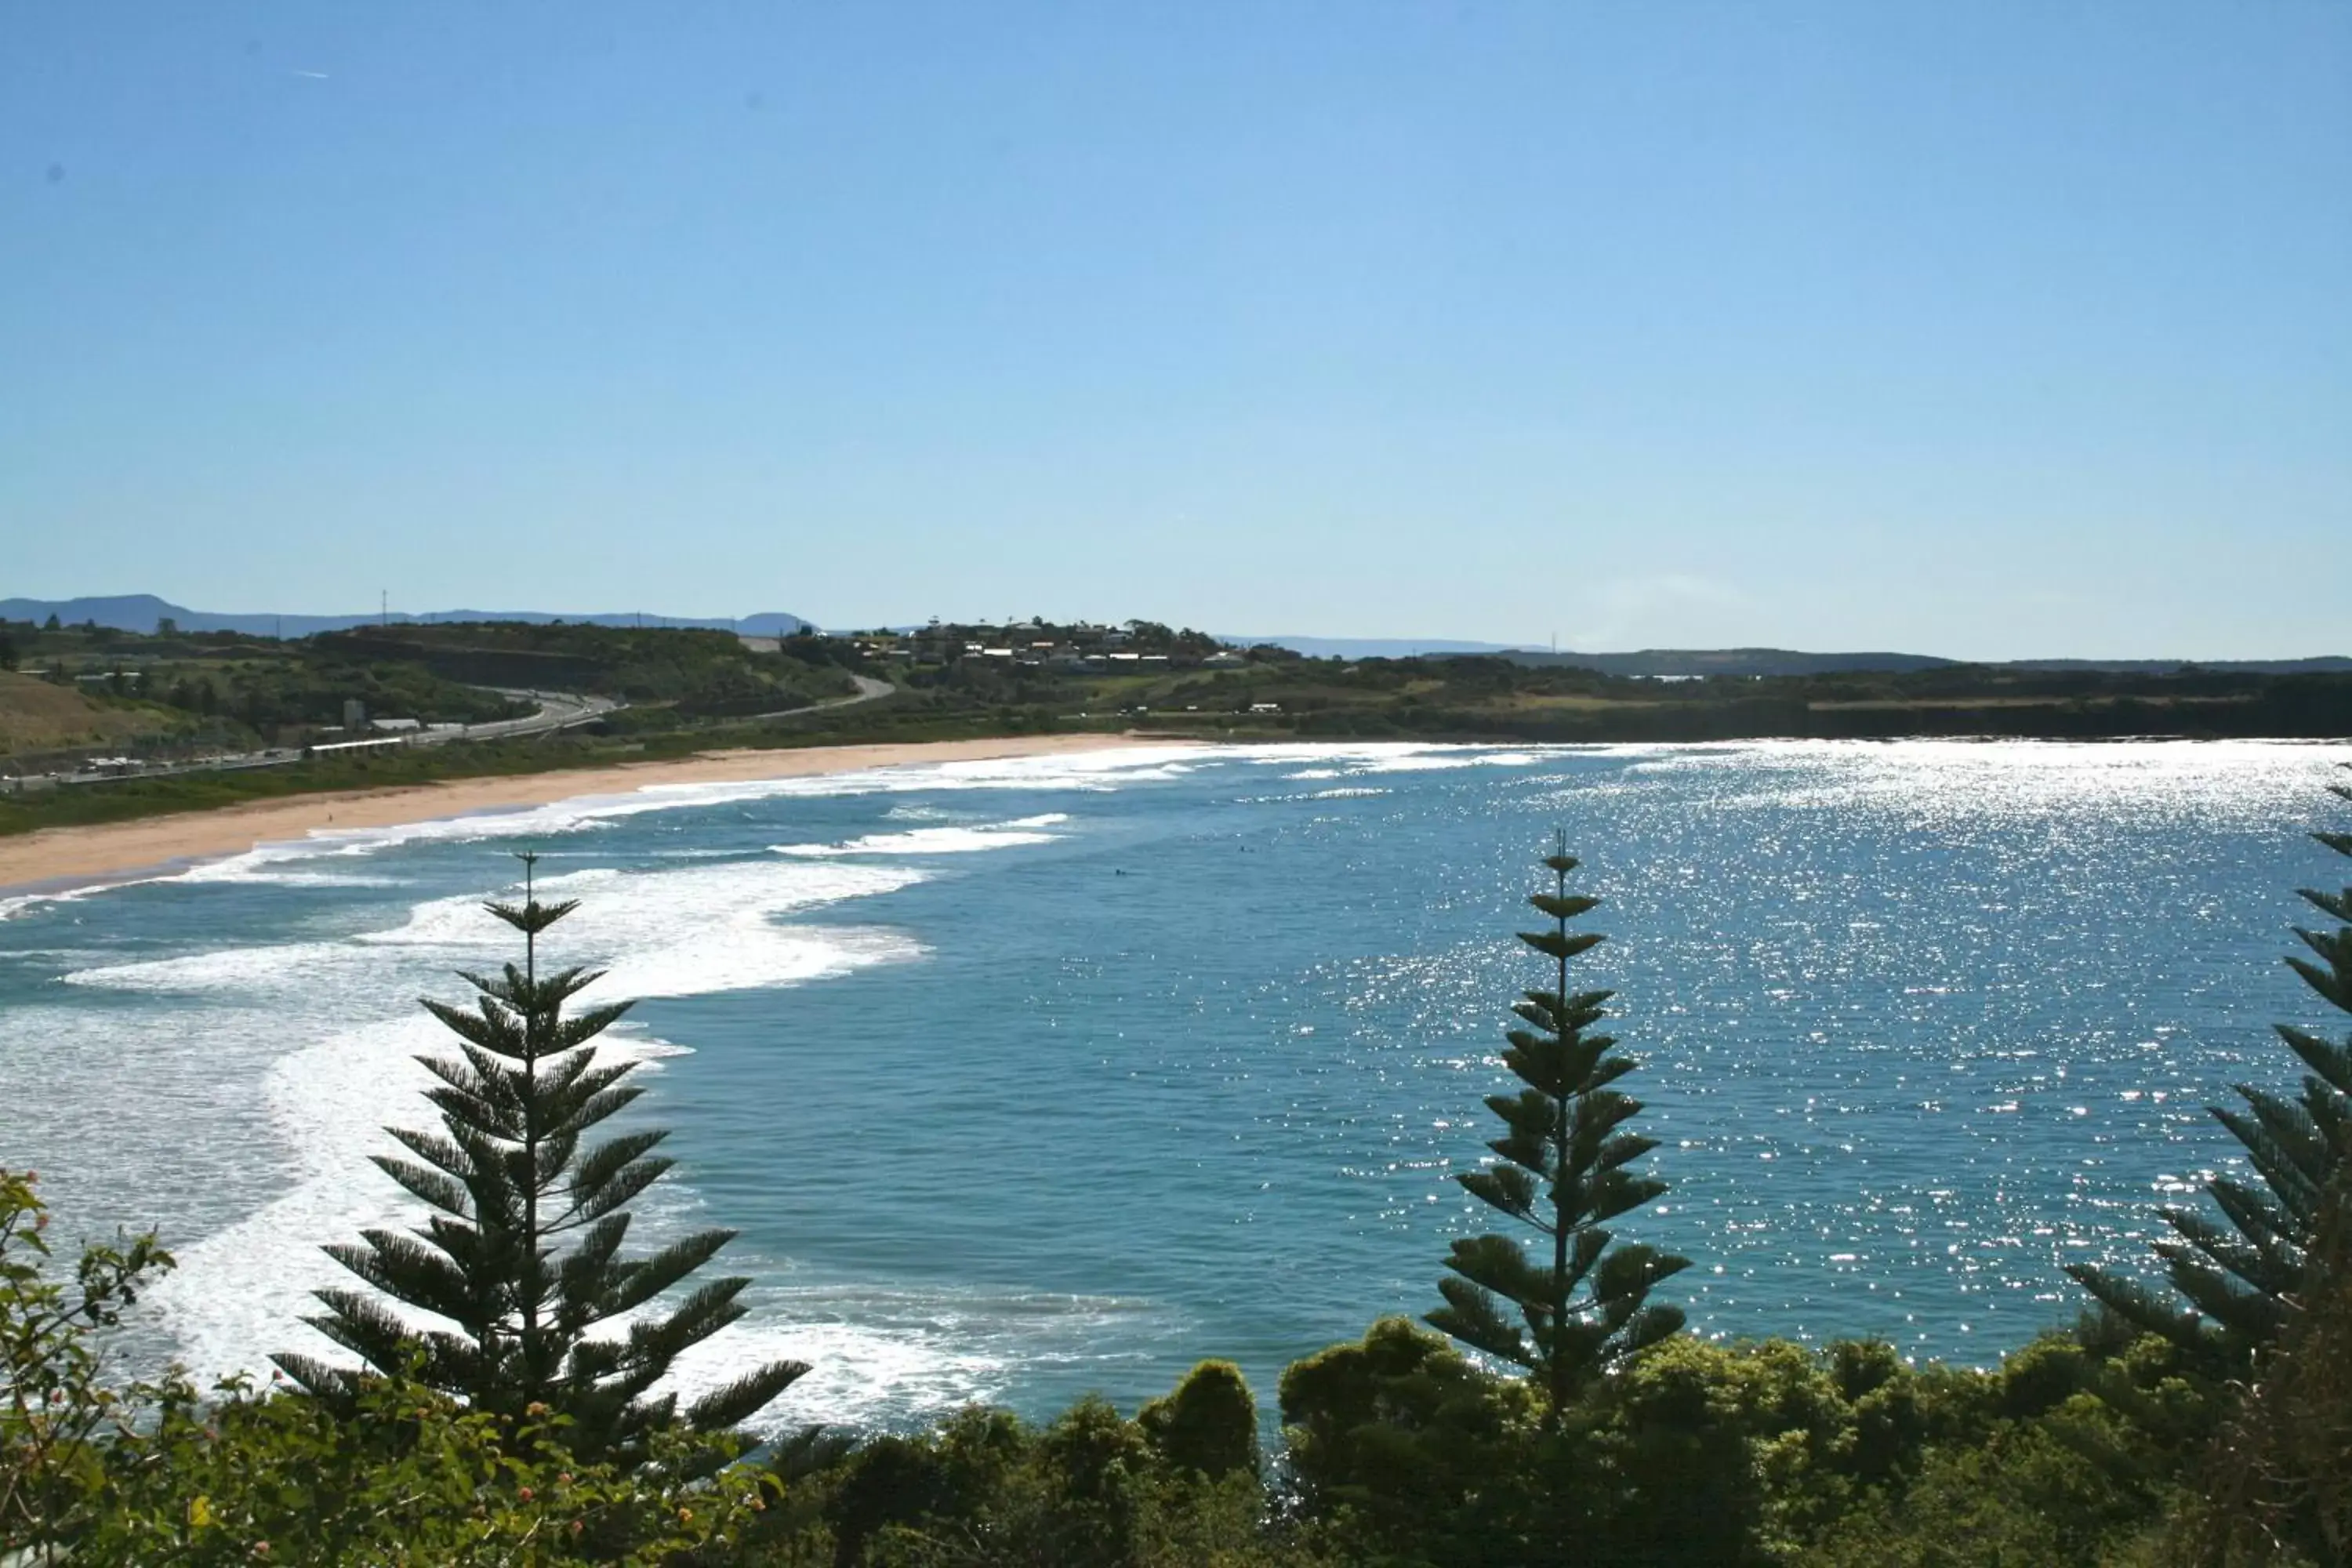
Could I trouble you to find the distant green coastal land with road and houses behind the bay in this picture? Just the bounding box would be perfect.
[0,607,2352,865]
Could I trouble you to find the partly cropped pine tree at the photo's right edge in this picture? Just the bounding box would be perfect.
[2067,764,2352,1370]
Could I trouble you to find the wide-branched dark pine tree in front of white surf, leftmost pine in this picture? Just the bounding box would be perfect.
[273,855,809,1465]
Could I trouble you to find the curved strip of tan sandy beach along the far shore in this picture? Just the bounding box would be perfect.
[0,736,1167,893]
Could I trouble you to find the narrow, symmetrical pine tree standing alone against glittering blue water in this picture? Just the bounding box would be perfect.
[1428,834,1691,1429]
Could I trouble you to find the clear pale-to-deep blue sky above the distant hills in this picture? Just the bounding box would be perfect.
[0,0,2352,656]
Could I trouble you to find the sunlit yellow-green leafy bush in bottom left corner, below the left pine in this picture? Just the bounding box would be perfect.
[0,1173,790,1568]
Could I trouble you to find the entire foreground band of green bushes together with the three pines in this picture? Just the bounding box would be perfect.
[0,766,2352,1568]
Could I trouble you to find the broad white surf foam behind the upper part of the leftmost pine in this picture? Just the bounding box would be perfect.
[117,858,922,1375]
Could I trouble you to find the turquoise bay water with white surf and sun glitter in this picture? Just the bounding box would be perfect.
[0,743,2347,1422]
